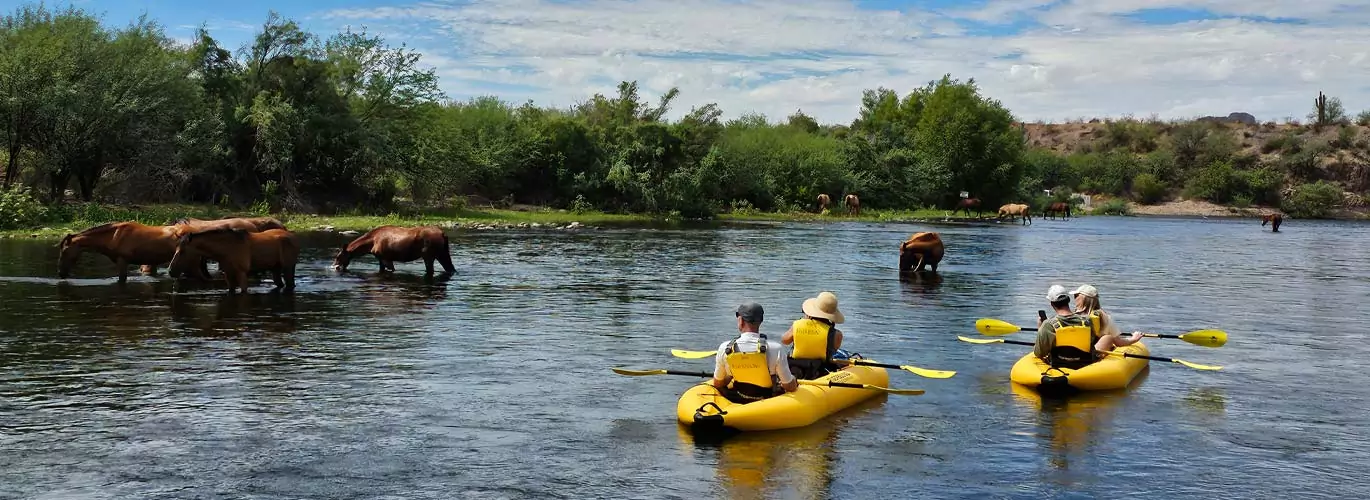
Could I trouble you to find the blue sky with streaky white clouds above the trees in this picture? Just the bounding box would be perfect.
[18,0,1370,123]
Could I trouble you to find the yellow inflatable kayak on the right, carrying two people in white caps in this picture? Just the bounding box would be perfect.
[1008,342,1151,392]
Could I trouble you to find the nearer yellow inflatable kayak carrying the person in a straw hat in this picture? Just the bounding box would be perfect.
[675,359,889,432]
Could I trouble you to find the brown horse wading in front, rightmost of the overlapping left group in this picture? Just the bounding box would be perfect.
[171,227,300,293]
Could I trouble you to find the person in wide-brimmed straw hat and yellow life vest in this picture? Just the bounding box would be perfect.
[781,292,845,379]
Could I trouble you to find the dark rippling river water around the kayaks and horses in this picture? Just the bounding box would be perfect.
[0,216,1370,499]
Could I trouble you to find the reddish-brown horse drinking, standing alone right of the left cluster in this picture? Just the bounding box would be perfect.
[333,226,456,274]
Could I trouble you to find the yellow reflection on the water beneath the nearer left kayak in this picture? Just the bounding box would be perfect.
[677,395,888,499]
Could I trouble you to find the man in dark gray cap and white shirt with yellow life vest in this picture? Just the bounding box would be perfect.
[714,303,799,403]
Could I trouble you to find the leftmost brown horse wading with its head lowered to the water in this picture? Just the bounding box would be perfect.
[58,221,190,282]
